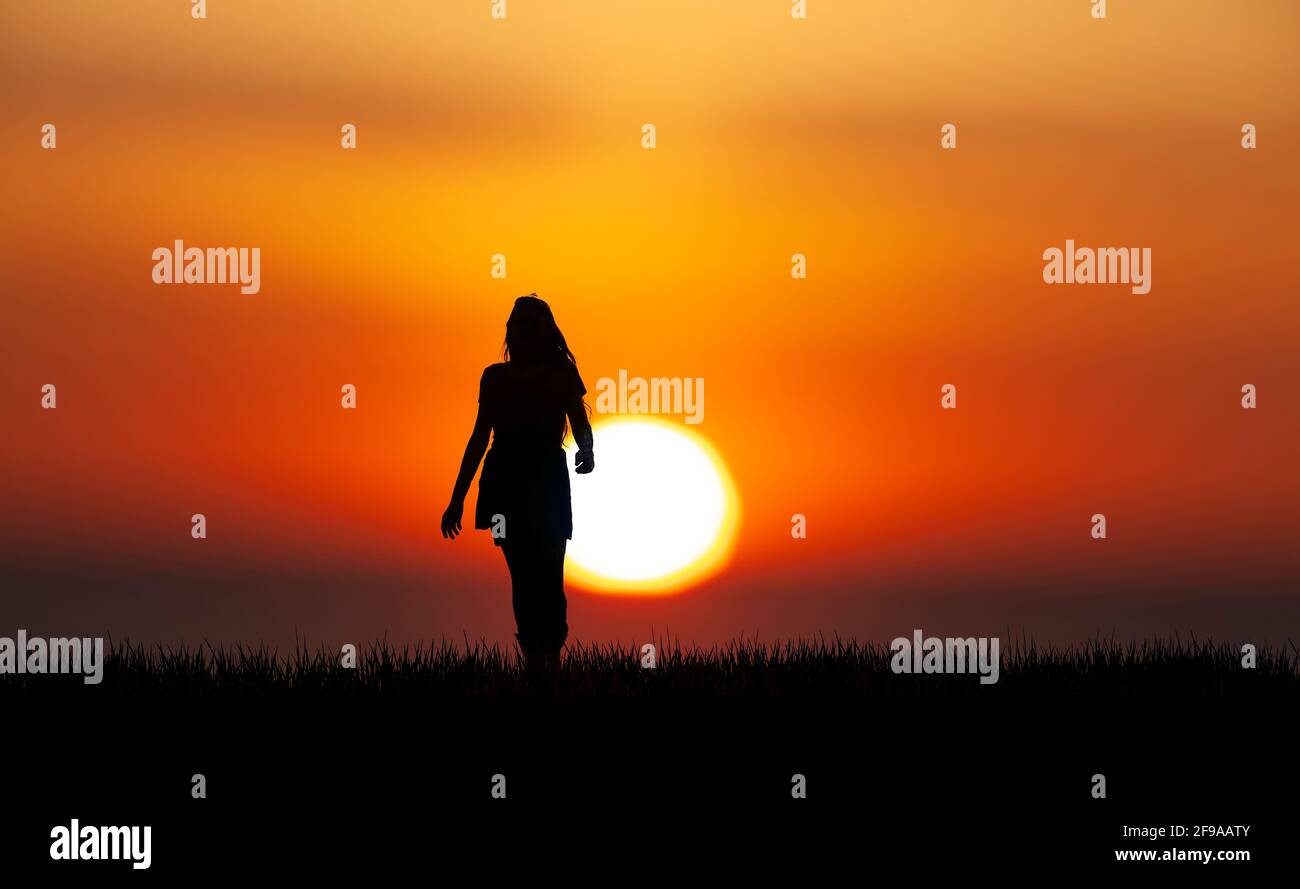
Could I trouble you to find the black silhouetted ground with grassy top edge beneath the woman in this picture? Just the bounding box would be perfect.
[0,643,1300,885]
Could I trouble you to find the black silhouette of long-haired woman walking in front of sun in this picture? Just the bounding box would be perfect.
[442,294,595,677]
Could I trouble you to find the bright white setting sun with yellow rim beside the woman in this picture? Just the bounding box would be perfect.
[566,417,740,594]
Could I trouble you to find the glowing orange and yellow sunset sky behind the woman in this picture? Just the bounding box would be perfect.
[0,0,1300,642]
